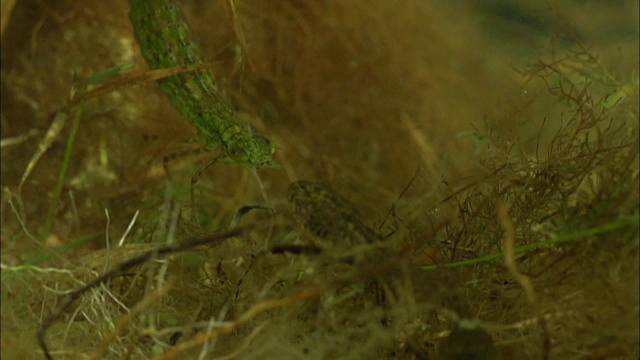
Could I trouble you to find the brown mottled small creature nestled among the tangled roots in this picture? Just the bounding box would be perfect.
[287,180,382,245]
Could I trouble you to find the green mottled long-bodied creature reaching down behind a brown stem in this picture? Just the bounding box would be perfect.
[129,0,275,168]
